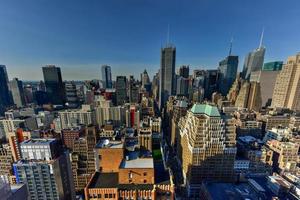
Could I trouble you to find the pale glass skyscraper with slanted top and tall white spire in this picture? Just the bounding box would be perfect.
[242,31,266,79]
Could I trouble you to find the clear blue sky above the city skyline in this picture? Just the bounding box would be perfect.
[0,0,300,80]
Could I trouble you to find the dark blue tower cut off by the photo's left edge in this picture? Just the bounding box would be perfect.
[0,65,11,114]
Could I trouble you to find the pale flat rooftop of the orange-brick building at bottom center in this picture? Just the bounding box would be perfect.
[120,158,154,169]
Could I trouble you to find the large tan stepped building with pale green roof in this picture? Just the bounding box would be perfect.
[179,104,236,199]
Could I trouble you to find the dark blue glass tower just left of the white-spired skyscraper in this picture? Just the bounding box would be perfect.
[218,51,239,96]
